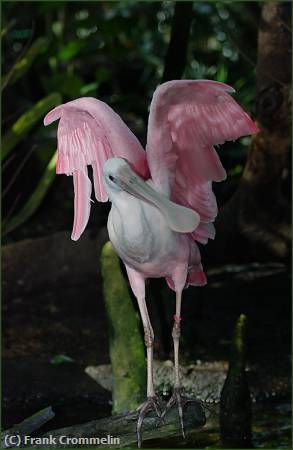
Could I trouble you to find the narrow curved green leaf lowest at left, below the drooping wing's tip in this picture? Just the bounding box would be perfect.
[3,150,57,234]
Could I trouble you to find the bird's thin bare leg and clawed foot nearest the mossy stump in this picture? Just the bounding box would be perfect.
[136,298,161,447]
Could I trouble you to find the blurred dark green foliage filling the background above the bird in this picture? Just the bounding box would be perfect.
[2,1,259,241]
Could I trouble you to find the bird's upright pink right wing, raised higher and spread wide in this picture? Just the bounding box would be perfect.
[147,80,258,243]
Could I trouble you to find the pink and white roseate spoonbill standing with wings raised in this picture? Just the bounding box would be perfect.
[44,80,258,446]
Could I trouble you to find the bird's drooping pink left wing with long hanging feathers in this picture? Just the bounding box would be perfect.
[44,97,149,240]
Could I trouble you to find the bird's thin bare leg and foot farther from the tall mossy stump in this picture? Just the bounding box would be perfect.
[162,291,203,438]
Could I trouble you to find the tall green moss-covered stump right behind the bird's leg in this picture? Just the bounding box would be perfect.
[101,242,146,414]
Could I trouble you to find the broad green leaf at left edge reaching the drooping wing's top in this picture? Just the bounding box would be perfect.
[1,92,62,160]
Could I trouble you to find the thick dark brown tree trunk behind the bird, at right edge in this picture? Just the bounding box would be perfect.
[207,2,291,260]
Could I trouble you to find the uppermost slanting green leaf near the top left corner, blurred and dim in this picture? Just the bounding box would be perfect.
[2,38,49,90]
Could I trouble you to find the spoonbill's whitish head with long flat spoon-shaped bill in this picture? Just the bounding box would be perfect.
[103,158,200,233]
